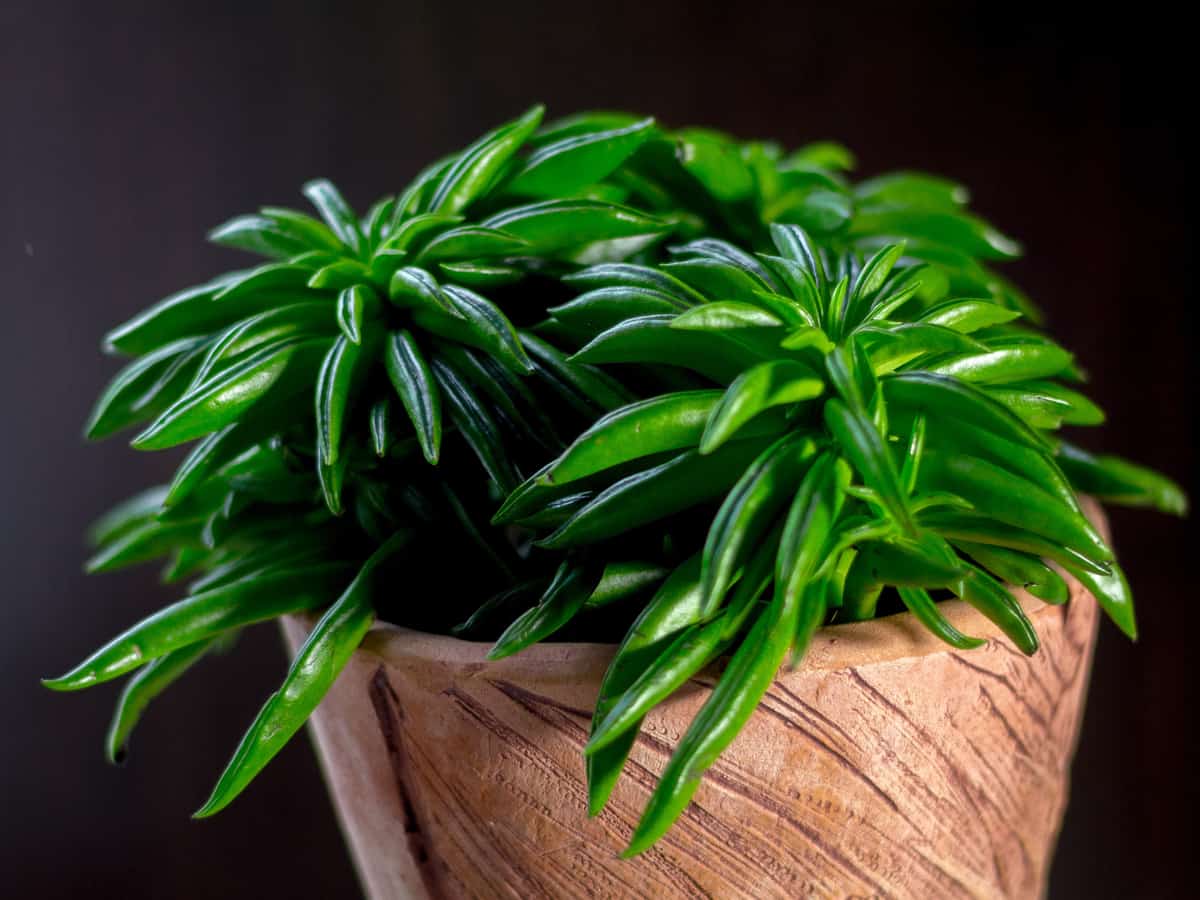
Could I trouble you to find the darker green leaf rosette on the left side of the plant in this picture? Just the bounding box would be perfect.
[88,107,668,512]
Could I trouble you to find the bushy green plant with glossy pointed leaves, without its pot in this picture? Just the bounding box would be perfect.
[47,107,1186,853]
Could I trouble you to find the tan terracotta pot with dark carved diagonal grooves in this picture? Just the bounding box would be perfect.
[286,510,1103,900]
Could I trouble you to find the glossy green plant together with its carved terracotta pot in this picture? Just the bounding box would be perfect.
[46,107,1186,896]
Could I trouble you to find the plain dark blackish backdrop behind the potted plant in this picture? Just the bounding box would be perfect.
[0,0,1200,899]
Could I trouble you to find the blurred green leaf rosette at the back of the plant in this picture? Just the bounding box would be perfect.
[540,113,1040,320]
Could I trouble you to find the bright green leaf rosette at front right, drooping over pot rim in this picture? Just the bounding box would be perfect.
[498,226,1186,853]
